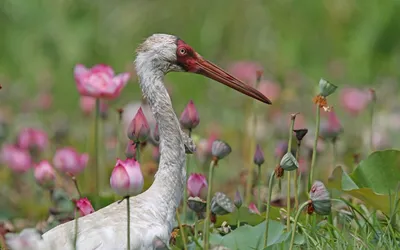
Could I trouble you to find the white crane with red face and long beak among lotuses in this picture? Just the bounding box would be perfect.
[4,34,270,250]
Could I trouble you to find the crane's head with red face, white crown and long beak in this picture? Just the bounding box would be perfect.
[136,34,271,104]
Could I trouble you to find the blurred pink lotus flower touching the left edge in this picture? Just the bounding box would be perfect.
[1,145,32,173]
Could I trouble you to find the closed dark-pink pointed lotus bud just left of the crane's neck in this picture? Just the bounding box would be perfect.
[128,107,150,143]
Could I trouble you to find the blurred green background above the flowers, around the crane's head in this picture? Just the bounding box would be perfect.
[0,0,400,112]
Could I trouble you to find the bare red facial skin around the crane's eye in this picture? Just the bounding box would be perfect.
[176,39,201,73]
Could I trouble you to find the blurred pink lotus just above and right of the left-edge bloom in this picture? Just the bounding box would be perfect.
[18,128,49,151]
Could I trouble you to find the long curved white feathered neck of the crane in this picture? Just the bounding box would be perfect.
[136,57,186,212]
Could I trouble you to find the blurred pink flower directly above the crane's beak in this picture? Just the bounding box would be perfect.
[228,61,269,86]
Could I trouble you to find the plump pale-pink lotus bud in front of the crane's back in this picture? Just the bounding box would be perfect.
[110,159,144,197]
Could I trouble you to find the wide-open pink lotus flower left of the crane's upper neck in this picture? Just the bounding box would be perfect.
[74,64,130,99]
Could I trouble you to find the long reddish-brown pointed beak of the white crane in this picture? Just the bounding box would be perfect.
[196,55,272,104]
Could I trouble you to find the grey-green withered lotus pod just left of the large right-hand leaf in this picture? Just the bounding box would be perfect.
[310,181,331,215]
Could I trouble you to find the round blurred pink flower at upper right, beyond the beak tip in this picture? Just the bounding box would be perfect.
[340,88,371,116]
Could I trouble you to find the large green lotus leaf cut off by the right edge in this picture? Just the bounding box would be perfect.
[350,149,400,194]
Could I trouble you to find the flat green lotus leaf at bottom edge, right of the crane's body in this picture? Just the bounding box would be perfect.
[210,220,286,250]
